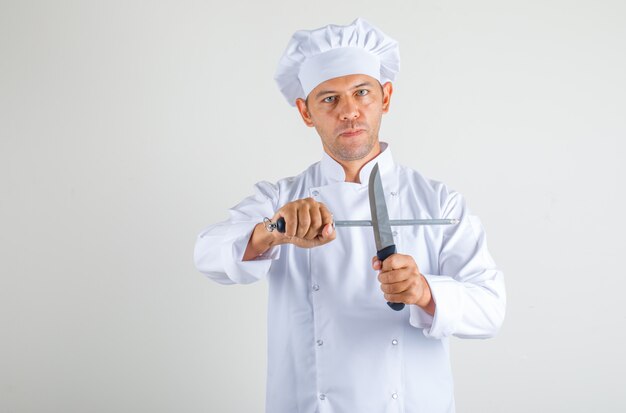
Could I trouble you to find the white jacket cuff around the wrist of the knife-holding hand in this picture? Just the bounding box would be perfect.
[409,274,464,339]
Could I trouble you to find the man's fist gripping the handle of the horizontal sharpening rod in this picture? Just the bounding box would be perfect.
[243,198,337,261]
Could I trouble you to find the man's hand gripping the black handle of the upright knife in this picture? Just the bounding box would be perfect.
[372,254,435,315]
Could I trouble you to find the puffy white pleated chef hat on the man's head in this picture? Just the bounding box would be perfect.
[274,18,400,106]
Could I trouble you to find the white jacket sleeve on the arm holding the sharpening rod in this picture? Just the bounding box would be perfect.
[193,182,280,284]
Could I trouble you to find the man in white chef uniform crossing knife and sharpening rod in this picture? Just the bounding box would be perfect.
[194,19,505,413]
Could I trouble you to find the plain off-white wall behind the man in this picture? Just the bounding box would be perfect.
[0,0,626,413]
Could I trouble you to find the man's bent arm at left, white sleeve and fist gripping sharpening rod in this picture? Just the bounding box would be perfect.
[194,182,336,284]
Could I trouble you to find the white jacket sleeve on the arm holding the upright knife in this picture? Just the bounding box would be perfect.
[410,192,506,339]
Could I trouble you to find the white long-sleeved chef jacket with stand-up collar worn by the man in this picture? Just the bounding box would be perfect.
[194,142,506,413]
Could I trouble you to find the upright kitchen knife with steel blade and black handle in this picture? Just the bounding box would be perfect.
[369,163,404,311]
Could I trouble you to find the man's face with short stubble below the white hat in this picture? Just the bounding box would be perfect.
[296,75,392,161]
